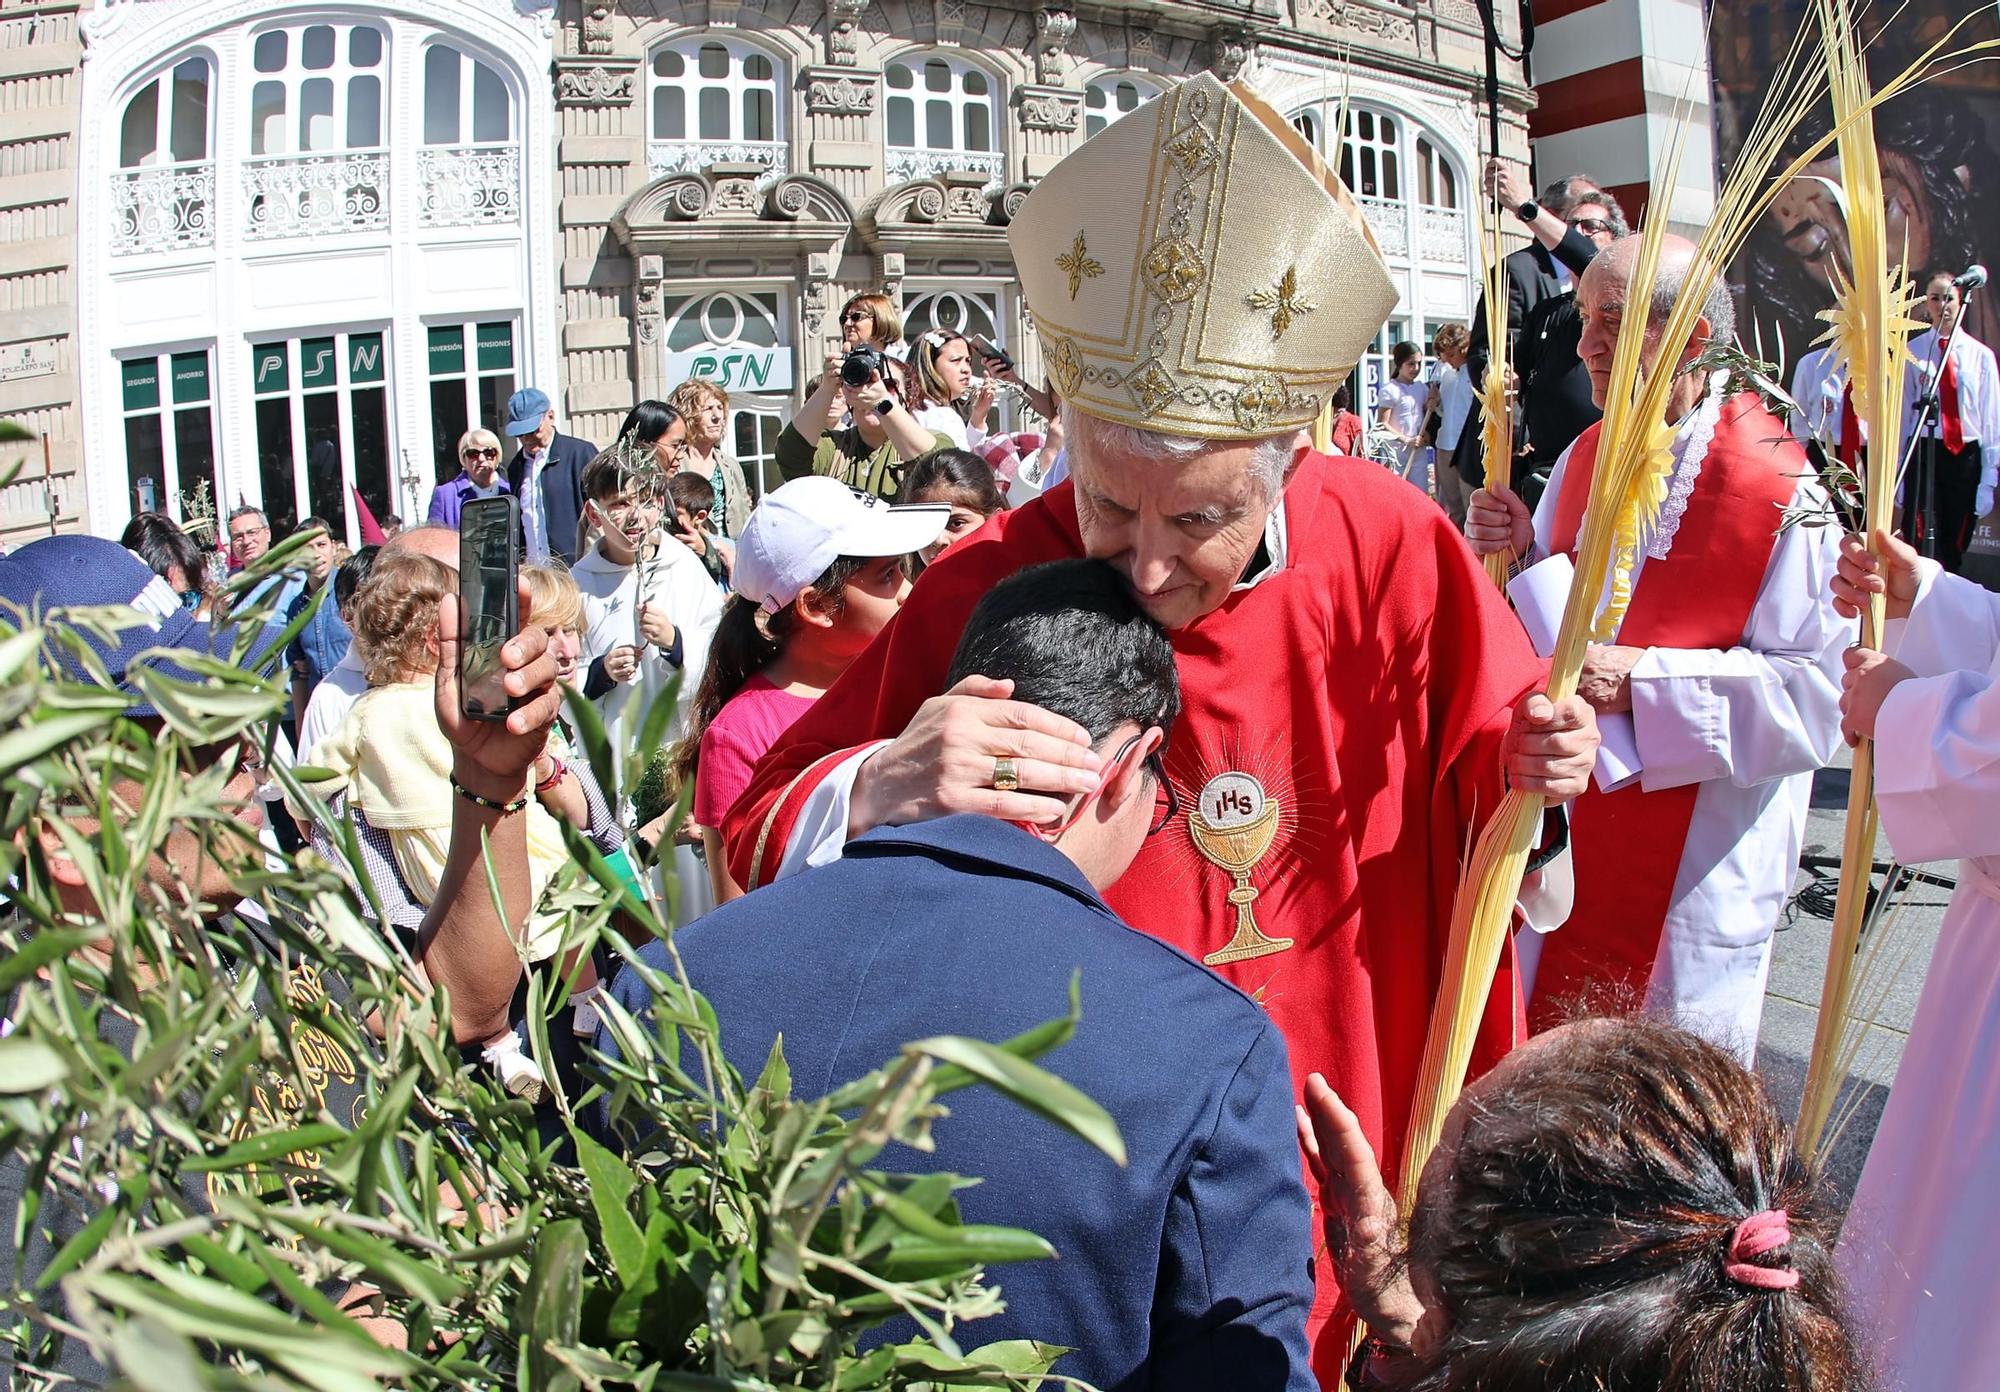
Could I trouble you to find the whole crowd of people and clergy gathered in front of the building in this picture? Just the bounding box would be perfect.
[0,78,2000,1392]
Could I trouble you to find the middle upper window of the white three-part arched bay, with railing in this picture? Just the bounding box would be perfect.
[242,24,388,242]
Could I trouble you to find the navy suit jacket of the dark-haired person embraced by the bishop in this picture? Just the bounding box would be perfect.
[598,814,1318,1392]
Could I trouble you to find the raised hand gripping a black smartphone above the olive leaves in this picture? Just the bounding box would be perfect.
[434,580,562,802]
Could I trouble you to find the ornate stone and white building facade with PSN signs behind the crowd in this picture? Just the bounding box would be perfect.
[27,0,1532,542]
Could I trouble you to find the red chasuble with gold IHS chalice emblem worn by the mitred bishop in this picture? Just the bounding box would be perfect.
[724,454,1546,1386]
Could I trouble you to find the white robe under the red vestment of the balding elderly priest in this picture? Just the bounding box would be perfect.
[1516,378,1854,1062]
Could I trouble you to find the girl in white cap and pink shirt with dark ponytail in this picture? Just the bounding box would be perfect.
[672,476,952,904]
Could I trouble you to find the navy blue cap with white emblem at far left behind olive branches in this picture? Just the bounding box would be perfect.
[0,536,292,716]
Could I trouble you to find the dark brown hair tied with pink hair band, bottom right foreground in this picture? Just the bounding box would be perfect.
[1404,1016,1868,1392]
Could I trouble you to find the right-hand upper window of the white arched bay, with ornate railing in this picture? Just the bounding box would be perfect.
[416,42,520,228]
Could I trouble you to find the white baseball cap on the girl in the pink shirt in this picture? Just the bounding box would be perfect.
[732,474,952,614]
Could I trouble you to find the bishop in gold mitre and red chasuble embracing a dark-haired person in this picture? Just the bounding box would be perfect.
[724,74,1596,1386]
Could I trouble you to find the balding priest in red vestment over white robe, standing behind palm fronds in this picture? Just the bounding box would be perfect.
[1466,238,1854,1062]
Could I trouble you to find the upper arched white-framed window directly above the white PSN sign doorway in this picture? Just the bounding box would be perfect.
[646,38,790,178]
